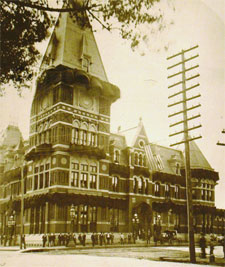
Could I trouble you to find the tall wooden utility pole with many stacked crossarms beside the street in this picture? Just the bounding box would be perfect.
[167,46,201,263]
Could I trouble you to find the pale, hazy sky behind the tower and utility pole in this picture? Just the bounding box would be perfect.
[0,0,225,208]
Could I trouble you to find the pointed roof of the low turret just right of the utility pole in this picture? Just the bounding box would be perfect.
[189,141,213,170]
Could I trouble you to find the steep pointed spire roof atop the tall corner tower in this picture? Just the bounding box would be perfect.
[40,12,108,82]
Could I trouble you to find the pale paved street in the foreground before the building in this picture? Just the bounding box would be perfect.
[0,247,225,267]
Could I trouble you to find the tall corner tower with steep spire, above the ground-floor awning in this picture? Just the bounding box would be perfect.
[26,13,120,231]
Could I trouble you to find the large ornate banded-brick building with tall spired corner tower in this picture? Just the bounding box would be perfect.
[0,14,225,239]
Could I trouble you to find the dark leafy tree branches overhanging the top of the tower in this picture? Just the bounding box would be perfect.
[0,0,161,93]
